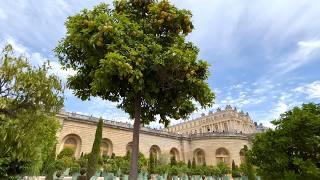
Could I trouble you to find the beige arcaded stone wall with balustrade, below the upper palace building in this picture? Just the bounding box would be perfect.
[57,112,249,165]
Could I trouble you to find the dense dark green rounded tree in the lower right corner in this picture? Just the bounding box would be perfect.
[247,103,320,179]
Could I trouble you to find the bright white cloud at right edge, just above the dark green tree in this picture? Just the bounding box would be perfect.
[293,81,320,99]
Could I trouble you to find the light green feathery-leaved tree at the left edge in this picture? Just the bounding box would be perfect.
[0,45,63,178]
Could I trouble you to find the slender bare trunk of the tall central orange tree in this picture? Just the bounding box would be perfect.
[129,95,141,180]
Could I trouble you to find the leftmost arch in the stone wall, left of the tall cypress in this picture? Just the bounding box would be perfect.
[59,134,82,157]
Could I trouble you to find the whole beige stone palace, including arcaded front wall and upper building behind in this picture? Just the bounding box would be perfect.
[57,106,255,165]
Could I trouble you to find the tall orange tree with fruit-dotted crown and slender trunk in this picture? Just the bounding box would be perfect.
[55,0,214,179]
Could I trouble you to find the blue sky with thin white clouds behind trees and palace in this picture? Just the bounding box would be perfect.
[0,0,320,126]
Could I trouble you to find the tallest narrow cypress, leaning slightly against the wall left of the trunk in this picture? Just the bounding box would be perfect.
[87,119,103,179]
